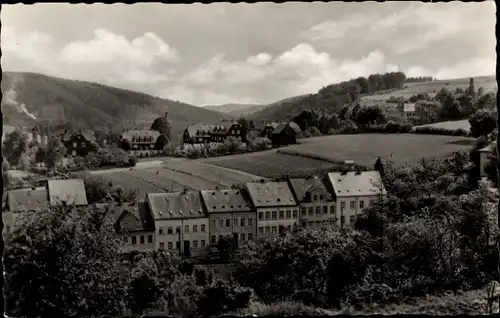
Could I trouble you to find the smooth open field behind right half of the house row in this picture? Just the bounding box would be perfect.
[204,134,475,178]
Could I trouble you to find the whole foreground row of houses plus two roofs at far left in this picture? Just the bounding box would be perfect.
[4,171,386,256]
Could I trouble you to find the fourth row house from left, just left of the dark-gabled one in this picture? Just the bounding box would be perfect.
[246,182,299,238]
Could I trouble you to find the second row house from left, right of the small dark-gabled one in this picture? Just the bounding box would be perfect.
[146,191,209,257]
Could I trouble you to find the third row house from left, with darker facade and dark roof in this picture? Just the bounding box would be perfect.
[201,189,257,245]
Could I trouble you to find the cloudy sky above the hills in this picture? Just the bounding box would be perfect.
[1,1,496,105]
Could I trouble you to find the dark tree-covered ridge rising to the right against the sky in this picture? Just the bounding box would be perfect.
[250,72,406,121]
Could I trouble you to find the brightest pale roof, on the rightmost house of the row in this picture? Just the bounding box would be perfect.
[328,170,387,197]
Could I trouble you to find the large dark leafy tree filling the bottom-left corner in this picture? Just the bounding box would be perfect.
[4,206,125,317]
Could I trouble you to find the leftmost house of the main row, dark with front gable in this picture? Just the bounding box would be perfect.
[99,201,155,253]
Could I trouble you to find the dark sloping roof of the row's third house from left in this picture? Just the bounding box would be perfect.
[201,189,252,213]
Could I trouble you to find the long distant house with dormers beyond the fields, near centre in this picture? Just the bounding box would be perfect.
[182,122,246,147]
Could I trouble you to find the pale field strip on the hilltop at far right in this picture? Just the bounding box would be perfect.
[361,76,498,101]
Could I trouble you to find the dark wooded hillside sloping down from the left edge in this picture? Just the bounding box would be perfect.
[2,72,230,145]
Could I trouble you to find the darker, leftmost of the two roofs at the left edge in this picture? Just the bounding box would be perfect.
[7,187,49,212]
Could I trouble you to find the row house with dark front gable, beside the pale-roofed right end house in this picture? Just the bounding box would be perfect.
[288,177,338,228]
